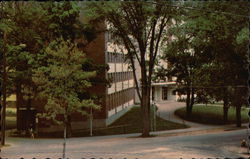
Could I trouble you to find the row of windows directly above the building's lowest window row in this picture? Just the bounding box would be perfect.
[108,71,133,83]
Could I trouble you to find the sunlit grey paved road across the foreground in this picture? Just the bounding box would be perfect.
[1,130,247,159]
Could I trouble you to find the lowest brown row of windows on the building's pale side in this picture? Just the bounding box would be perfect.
[107,88,135,110]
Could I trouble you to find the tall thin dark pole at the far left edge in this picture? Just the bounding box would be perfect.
[1,31,7,145]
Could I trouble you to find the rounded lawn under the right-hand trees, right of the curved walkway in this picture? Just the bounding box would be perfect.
[175,104,249,125]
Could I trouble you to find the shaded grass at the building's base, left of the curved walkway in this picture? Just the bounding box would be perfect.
[36,107,188,137]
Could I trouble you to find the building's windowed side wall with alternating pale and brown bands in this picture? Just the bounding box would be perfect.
[106,42,135,123]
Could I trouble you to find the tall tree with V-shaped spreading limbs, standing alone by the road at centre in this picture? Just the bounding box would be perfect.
[88,1,178,137]
